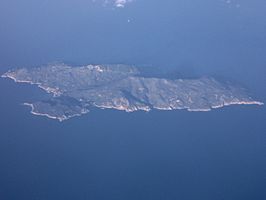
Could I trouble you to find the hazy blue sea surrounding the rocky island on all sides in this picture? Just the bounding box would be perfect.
[0,0,266,200]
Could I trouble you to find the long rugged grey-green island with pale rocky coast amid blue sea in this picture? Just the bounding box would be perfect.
[2,63,263,121]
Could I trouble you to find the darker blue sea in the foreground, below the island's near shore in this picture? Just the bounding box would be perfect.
[0,77,266,200]
